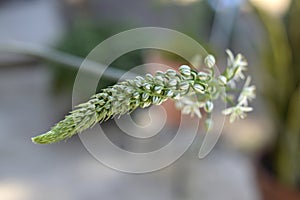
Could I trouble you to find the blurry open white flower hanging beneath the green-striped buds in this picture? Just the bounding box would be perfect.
[175,97,204,118]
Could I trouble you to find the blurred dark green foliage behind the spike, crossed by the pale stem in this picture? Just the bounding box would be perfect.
[49,19,142,92]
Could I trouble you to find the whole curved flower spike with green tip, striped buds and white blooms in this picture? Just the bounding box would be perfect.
[32,51,255,144]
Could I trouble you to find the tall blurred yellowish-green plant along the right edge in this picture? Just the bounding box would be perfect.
[257,0,300,188]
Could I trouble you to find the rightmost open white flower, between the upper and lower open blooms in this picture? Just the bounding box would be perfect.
[238,76,256,106]
